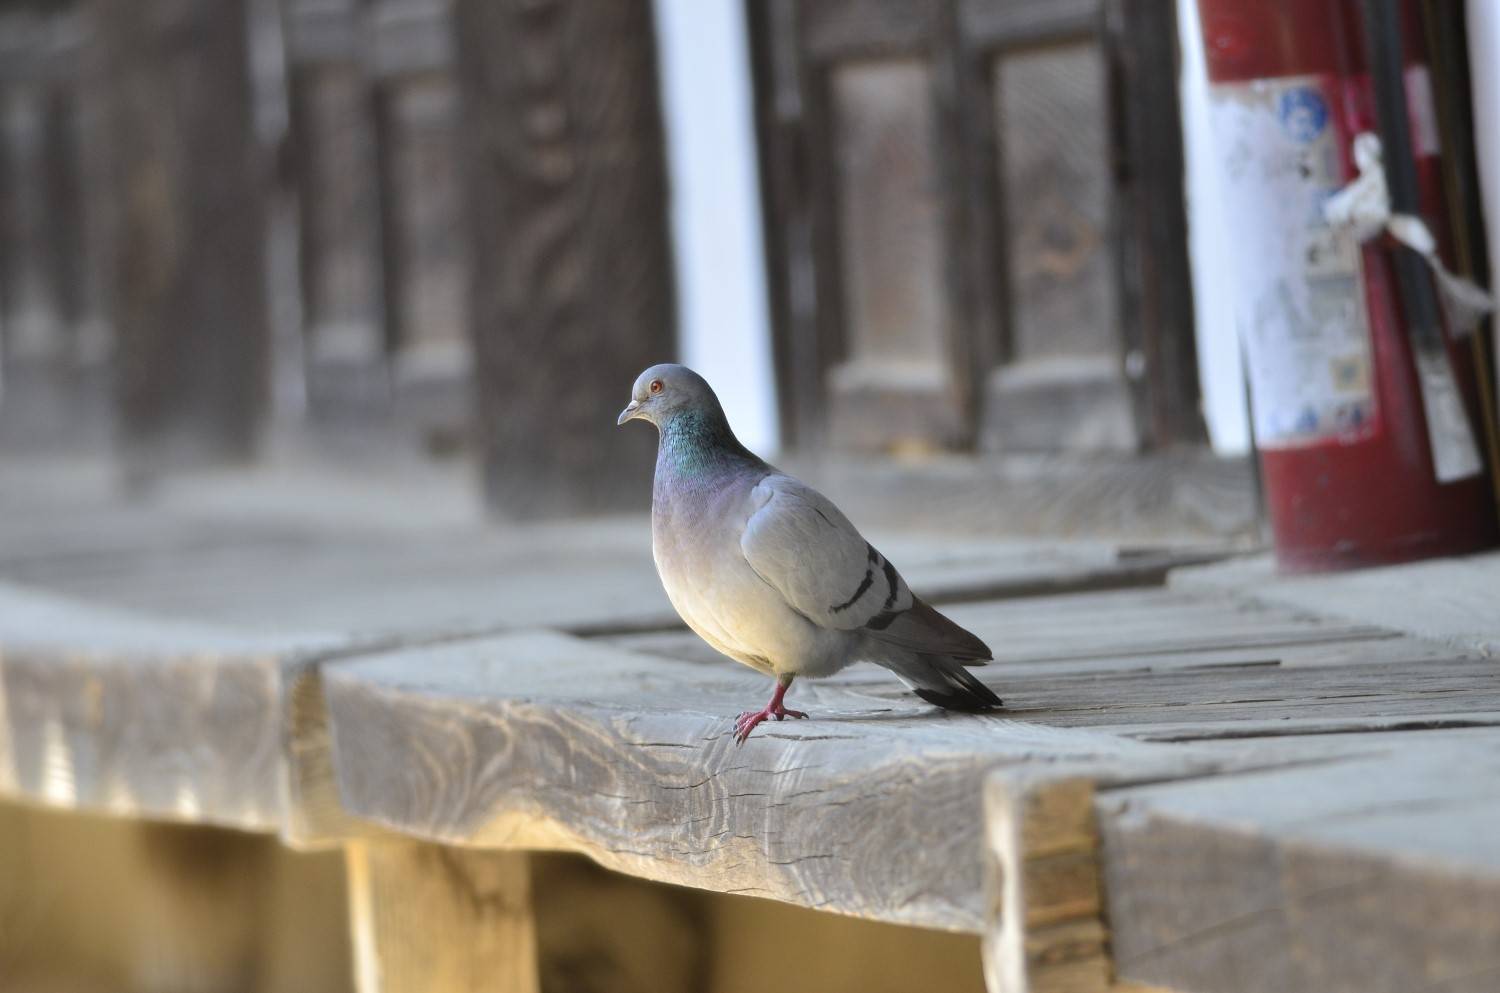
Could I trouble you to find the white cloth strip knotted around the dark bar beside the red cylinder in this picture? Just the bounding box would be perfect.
[1323,131,1496,335]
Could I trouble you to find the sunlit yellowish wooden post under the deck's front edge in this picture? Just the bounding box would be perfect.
[345,842,540,993]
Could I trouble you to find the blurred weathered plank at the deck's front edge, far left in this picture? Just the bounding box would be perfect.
[0,585,357,843]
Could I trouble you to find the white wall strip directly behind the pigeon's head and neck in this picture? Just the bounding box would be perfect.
[656,0,777,453]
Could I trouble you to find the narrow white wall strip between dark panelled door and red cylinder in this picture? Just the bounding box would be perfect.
[1178,0,1250,455]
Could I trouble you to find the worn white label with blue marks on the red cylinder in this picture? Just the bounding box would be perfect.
[1211,77,1376,449]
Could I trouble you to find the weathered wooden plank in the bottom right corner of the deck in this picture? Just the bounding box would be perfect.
[1097,731,1500,993]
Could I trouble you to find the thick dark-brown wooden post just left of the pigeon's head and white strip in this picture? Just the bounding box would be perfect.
[455,0,675,518]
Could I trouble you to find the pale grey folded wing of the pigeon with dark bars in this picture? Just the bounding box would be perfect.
[740,476,992,660]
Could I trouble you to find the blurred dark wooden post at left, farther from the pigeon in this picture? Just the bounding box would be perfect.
[96,0,269,474]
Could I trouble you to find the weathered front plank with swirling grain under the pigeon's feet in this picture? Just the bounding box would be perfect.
[324,633,1218,930]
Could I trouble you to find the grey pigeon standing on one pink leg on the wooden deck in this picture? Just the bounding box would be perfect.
[617,363,1001,744]
